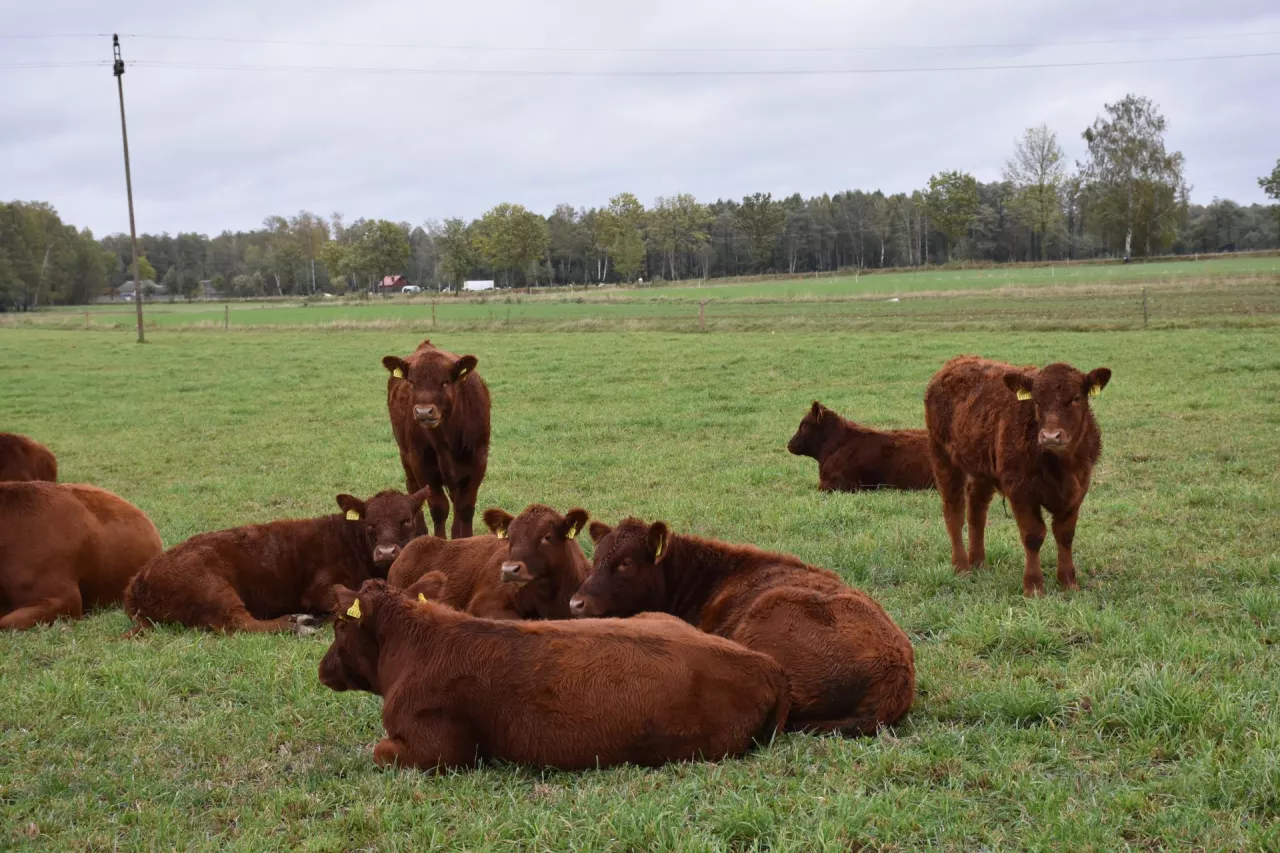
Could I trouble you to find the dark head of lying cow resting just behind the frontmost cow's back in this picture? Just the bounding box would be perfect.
[568,519,671,616]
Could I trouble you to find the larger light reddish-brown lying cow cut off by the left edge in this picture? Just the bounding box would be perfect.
[0,483,164,629]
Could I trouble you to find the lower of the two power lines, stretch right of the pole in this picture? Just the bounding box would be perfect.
[110,51,1280,77]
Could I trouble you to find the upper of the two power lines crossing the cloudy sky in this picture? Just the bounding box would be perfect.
[0,31,1280,54]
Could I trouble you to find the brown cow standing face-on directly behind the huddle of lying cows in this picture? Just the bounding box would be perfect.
[383,339,489,539]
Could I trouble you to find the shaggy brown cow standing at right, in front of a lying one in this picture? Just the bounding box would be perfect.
[924,356,1111,596]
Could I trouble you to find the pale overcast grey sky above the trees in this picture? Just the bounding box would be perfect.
[0,0,1280,236]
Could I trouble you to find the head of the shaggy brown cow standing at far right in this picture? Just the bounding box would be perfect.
[1005,364,1111,455]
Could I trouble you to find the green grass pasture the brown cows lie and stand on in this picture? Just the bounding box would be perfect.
[0,317,1280,850]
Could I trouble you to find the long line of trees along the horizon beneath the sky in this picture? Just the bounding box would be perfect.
[0,95,1280,307]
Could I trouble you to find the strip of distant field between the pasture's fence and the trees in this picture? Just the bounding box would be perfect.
[10,256,1280,332]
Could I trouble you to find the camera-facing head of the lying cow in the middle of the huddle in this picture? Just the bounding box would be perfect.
[484,503,590,583]
